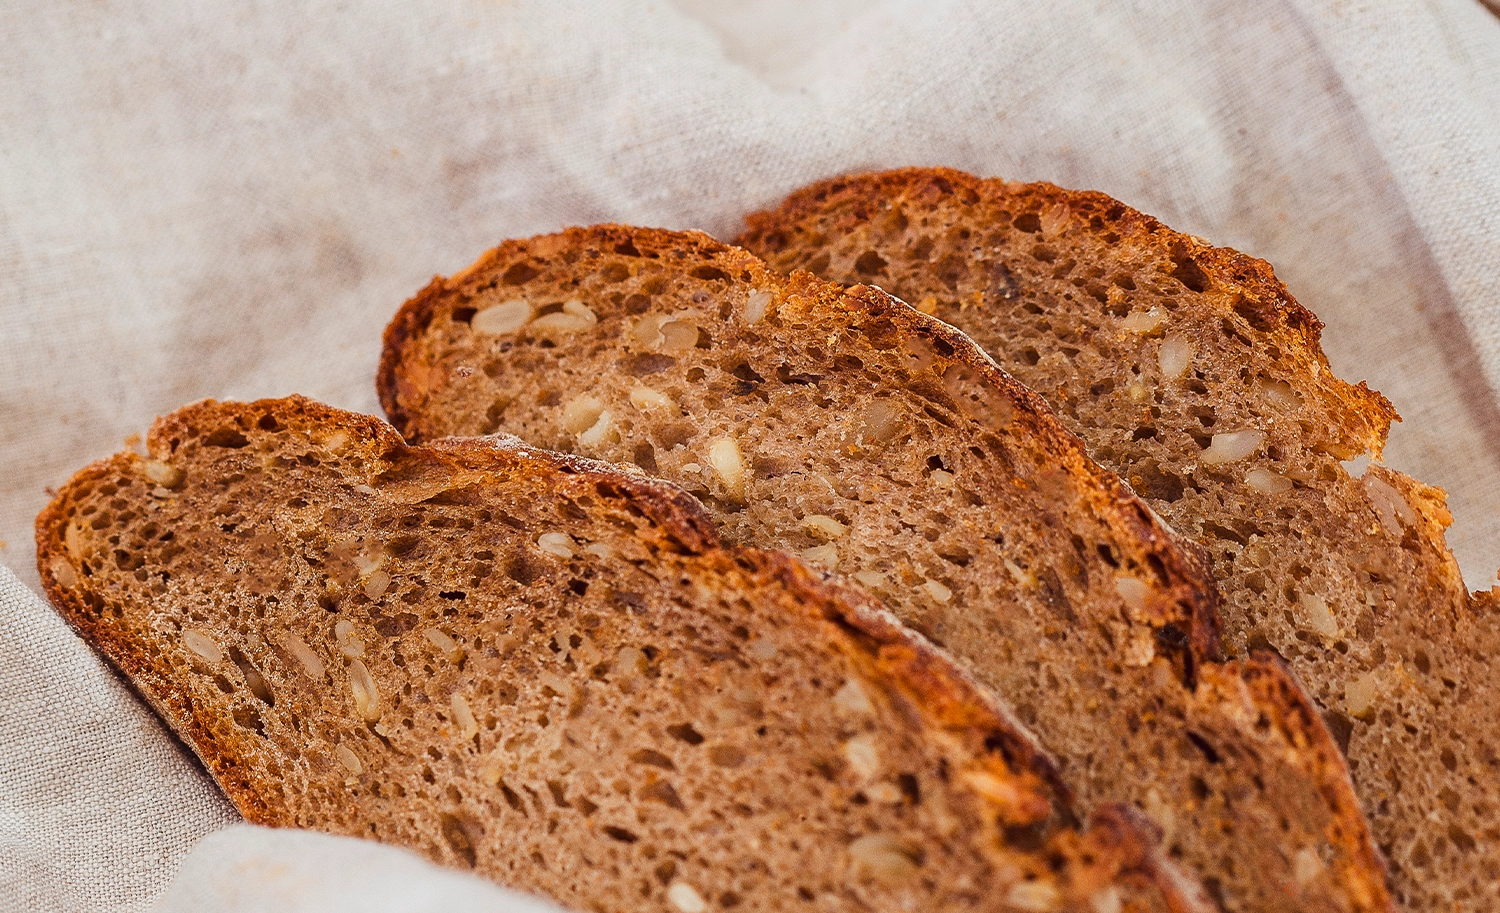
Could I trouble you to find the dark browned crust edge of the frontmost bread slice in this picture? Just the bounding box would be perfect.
[36,397,1206,912]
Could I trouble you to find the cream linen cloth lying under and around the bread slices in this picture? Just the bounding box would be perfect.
[0,0,1500,913]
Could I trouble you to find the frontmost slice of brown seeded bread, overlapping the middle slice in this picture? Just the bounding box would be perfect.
[38,399,1200,913]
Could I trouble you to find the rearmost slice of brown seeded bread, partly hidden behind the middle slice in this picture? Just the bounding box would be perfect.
[743,169,1500,910]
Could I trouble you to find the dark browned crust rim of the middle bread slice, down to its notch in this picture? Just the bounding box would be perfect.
[377,223,1223,668]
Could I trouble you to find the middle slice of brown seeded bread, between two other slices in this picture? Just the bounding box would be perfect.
[380,226,1386,910]
